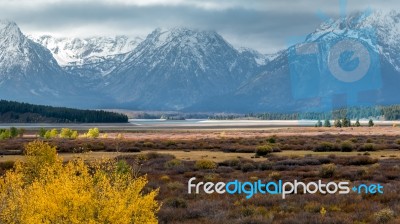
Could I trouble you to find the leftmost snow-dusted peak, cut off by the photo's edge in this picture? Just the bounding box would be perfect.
[0,21,76,105]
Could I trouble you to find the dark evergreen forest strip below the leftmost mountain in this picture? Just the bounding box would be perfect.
[0,100,128,123]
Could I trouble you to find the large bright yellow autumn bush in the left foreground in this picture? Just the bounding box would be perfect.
[0,141,159,224]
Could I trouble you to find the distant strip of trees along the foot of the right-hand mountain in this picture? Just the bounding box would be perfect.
[209,105,400,120]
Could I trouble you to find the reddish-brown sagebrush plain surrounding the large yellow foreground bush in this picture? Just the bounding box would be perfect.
[0,127,400,223]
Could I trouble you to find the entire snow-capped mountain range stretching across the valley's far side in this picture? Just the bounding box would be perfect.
[0,11,400,112]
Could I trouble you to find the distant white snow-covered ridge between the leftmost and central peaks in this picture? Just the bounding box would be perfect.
[31,35,142,81]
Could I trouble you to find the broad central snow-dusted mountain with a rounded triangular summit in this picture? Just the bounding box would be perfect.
[104,28,259,109]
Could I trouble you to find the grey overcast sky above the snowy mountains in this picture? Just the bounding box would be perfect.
[0,0,400,53]
